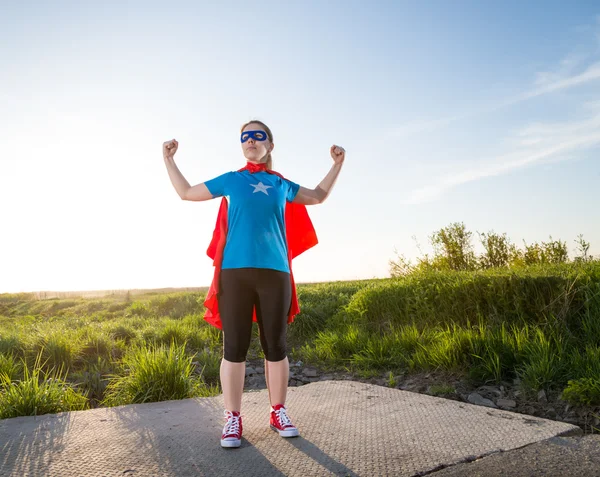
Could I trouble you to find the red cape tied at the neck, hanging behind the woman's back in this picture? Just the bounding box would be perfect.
[204,164,318,329]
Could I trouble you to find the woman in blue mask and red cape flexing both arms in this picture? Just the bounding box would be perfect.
[163,121,345,447]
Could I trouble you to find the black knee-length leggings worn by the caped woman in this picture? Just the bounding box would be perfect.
[219,268,292,363]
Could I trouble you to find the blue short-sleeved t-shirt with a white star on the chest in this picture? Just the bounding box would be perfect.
[205,171,300,273]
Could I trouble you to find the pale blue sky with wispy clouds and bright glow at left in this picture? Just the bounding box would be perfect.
[0,0,600,293]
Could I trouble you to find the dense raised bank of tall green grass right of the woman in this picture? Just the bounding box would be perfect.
[300,263,600,400]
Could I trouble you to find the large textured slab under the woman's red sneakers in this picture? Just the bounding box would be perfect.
[0,381,580,477]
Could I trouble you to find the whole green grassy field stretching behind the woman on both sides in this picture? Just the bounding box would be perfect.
[0,261,600,430]
